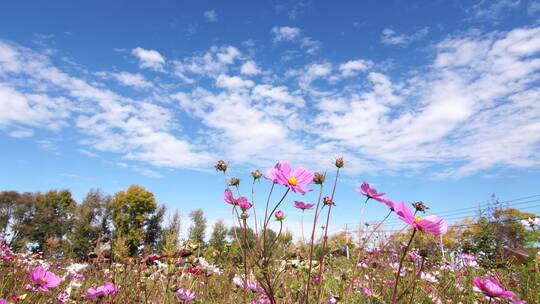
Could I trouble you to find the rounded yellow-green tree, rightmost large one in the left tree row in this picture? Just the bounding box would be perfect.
[111,185,157,256]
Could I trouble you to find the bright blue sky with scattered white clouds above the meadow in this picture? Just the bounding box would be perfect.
[0,0,540,236]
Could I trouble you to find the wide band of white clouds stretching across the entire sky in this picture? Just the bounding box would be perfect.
[0,26,540,177]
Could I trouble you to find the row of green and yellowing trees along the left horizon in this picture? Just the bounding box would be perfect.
[0,185,249,260]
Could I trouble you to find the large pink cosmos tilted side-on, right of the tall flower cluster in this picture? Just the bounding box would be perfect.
[394,202,448,236]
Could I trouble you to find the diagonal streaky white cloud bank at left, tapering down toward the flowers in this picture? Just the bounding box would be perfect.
[0,42,213,172]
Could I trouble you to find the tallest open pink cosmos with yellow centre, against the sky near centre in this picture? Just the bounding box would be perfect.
[266,162,315,194]
